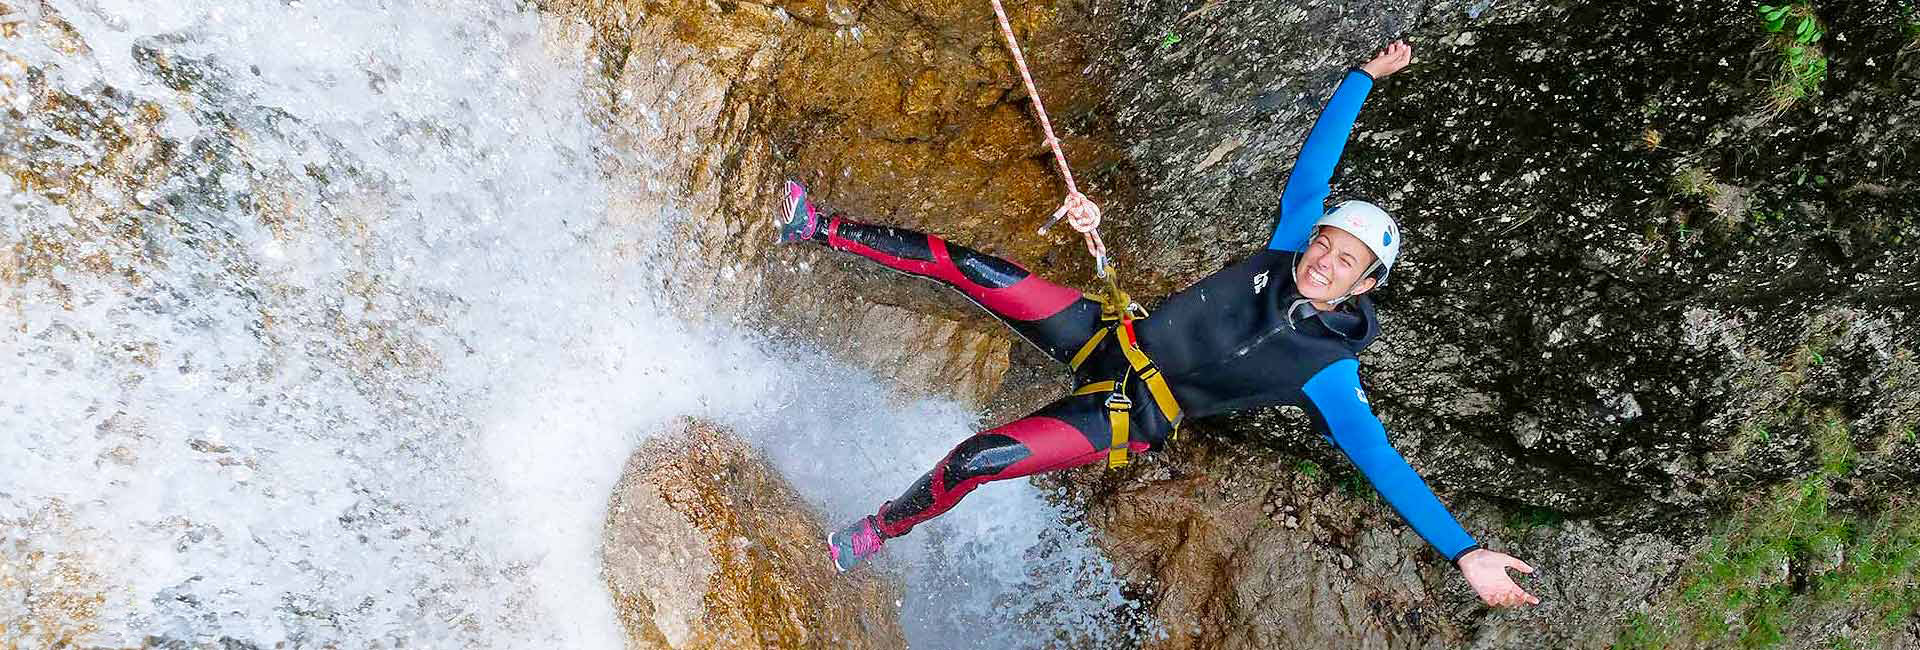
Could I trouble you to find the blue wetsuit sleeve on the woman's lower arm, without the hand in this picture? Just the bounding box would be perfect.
[1304,359,1480,560]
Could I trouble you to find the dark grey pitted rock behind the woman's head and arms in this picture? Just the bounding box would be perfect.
[1112,2,1920,514]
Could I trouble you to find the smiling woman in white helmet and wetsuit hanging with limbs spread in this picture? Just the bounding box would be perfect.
[781,42,1540,606]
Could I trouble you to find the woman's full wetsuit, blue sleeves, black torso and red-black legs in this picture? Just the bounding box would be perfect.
[816,69,1478,560]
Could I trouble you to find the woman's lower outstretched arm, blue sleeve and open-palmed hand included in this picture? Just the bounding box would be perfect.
[1302,359,1540,606]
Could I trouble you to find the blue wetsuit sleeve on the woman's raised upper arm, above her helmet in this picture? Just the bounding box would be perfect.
[1267,69,1373,251]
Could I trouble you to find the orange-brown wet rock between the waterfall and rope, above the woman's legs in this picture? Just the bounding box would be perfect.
[543,0,1117,403]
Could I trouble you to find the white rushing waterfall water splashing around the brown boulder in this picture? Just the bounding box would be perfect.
[0,0,1125,648]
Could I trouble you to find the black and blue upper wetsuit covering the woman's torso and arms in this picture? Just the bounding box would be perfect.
[1139,69,1478,560]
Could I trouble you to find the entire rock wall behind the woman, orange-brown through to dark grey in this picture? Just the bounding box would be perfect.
[568,0,1920,648]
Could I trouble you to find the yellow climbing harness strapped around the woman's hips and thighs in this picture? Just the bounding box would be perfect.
[1068,268,1181,468]
